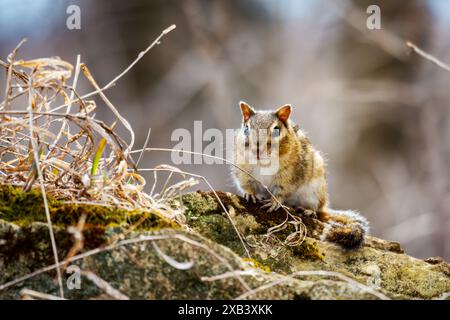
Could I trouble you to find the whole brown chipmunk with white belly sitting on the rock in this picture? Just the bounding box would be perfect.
[232,101,368,249]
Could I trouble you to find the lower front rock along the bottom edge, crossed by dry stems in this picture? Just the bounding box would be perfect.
[0,220,384,299]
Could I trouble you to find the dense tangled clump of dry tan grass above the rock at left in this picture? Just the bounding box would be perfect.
[0,33,181,216]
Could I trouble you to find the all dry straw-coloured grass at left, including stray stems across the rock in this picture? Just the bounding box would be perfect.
[0,26,260,299]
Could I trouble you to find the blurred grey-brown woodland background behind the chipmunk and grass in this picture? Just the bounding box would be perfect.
[0,0,450,260]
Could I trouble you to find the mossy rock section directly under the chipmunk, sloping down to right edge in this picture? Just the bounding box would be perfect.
[175,192,450,299]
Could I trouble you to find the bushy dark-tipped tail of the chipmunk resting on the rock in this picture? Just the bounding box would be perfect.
[321,208,369,249]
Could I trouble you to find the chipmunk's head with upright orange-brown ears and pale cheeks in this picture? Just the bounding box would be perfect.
[238,101,293,161]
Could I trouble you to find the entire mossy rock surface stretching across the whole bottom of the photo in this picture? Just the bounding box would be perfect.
[0,186,450,299]
